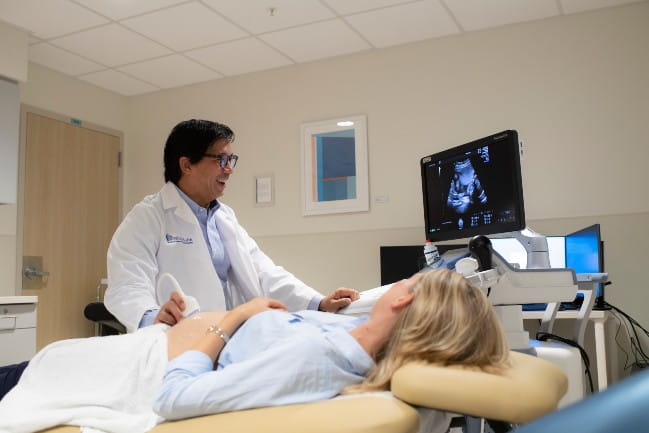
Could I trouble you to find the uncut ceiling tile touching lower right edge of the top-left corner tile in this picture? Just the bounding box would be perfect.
[50,24,171,66]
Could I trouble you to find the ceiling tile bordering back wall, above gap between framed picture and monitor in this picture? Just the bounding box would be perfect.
[345,0,460,47]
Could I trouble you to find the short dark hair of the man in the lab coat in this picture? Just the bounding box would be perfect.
[164,119,234,184]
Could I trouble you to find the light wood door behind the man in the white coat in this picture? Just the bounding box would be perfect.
[22,113,120,349]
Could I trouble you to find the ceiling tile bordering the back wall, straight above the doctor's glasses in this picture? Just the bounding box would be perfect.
[185,38,292,75]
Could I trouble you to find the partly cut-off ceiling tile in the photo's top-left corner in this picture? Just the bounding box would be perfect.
[0,0,108,39]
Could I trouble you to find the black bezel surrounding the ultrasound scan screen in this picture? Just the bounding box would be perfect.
[419,129,525,242]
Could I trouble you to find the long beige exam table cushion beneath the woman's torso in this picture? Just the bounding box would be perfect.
[38,395,419,433]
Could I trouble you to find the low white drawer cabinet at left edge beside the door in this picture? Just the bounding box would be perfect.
[0,296,38,366]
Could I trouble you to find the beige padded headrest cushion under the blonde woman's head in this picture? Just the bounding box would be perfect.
[392,352,568,424]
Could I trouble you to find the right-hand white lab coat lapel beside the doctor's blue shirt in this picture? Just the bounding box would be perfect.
[215,210,265,300]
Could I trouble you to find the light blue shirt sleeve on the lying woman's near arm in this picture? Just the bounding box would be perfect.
[154,330,374,419]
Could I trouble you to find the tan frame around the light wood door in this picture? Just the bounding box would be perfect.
[14,104,124,296]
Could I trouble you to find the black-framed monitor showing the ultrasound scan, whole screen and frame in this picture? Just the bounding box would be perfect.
[420,130,525,242]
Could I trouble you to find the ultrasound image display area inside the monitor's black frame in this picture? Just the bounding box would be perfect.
[425,142,516,233]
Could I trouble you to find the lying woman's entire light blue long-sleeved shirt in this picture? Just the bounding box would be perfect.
[154,311,374,419]
